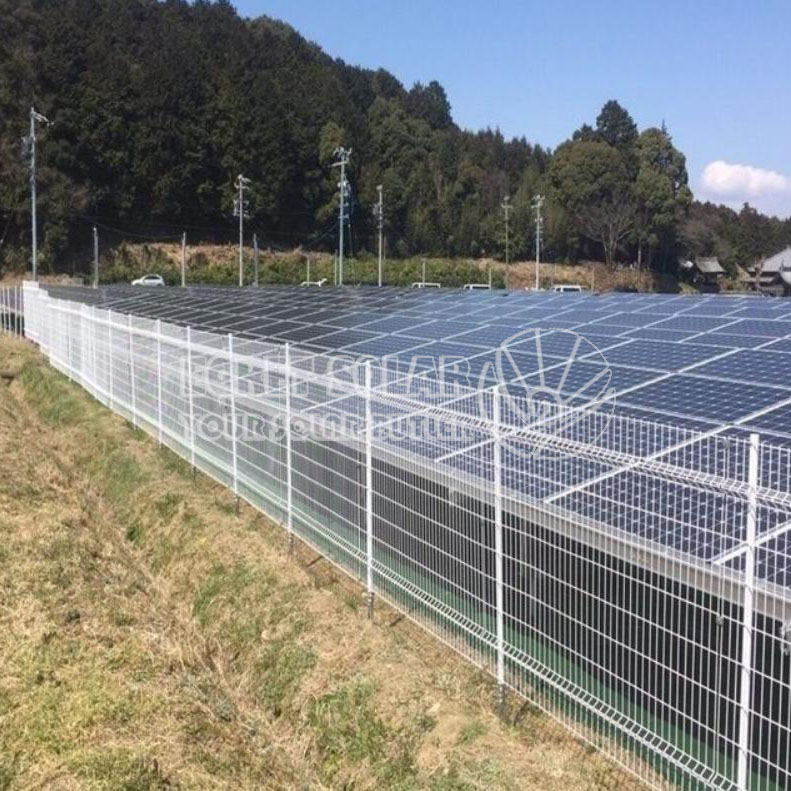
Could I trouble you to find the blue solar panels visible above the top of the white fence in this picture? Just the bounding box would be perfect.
[44,287,791,441]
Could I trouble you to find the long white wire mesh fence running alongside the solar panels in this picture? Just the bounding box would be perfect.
[18,285,791,791]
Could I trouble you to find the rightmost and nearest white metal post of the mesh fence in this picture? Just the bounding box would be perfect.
[736,434,759,791]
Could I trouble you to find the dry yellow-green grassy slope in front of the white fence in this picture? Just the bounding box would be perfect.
[0,338,644,791]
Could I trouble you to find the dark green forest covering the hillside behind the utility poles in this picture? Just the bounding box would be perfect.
[0,0,791,272]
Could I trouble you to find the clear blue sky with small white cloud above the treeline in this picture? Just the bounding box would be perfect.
[235,0,791,216]
